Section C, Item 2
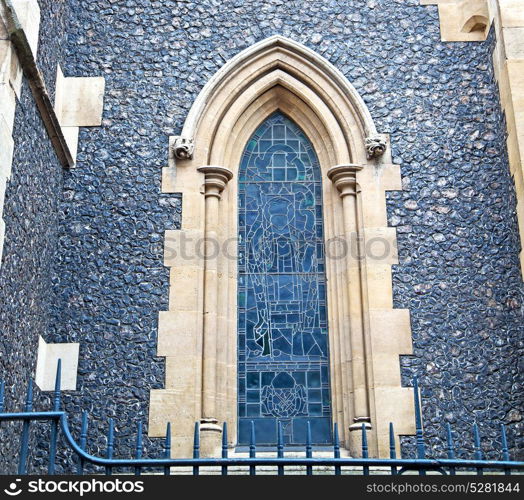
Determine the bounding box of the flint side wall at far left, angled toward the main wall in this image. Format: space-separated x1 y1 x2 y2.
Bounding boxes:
0 0 67 472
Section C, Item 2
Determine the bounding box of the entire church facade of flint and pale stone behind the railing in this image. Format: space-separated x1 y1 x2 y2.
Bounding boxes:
0 0 524 463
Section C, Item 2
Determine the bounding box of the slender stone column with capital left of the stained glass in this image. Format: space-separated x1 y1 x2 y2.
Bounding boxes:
198 166 233 456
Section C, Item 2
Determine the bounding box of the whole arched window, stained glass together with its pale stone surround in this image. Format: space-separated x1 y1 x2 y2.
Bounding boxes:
154 36 414 456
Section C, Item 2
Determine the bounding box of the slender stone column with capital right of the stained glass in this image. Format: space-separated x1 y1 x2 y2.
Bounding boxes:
327 165 371 438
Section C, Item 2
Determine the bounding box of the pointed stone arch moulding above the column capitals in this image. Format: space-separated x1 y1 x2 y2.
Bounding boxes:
172 35 385 168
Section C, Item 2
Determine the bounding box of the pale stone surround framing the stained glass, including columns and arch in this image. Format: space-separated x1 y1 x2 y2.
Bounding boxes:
149 36 414 456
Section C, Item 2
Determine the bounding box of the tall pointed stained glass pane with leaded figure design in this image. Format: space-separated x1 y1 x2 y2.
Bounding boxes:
238 113 331 444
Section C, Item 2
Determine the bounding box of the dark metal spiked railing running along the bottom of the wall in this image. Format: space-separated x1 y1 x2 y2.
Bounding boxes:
0 361 524 475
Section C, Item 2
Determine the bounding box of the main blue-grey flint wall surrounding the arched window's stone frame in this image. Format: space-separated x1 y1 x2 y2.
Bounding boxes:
0 0 524 468
